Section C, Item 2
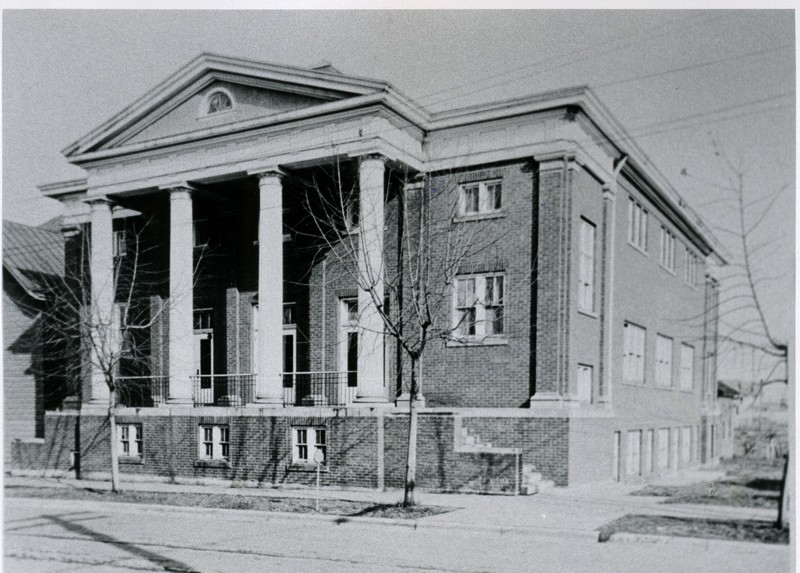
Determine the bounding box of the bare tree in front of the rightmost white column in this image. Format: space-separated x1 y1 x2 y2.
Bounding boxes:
303 163 529 506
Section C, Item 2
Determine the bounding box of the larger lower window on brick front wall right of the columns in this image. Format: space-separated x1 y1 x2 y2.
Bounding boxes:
453 274 505 339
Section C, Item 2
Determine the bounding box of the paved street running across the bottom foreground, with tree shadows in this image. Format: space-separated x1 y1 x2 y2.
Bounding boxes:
4 498 789 573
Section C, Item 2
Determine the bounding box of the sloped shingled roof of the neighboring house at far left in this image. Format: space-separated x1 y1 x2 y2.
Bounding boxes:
3 220 64 300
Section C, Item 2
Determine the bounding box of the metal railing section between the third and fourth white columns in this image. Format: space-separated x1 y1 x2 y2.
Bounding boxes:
282 372 357 406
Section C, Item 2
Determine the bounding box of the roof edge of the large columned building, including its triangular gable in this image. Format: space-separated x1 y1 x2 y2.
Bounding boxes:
48 53 727 264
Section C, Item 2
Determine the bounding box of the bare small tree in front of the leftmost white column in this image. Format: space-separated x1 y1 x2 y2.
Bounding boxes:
44 216 177 492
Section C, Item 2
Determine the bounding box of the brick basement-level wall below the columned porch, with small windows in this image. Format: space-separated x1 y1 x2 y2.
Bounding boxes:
42 410 569 493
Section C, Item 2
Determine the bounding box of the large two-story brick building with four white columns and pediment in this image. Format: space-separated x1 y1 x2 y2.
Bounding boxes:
36 54 724 490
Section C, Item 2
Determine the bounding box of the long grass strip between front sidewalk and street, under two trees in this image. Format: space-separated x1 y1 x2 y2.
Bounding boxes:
5 486 452 519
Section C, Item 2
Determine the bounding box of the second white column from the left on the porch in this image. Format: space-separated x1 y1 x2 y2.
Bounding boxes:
167 187 194 404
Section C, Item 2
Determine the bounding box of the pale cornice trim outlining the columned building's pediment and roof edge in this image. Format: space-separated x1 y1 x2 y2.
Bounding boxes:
50 53 727 264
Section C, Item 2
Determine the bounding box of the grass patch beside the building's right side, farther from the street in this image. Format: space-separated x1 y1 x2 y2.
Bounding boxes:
631 458 783 510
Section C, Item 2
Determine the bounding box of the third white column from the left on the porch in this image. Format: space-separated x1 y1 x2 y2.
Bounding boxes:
255 171 283 405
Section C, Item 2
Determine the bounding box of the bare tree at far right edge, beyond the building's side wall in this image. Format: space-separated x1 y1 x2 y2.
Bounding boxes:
683 141 789 528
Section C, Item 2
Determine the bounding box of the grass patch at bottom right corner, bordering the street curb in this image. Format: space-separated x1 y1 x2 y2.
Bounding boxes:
599 515 789 545
